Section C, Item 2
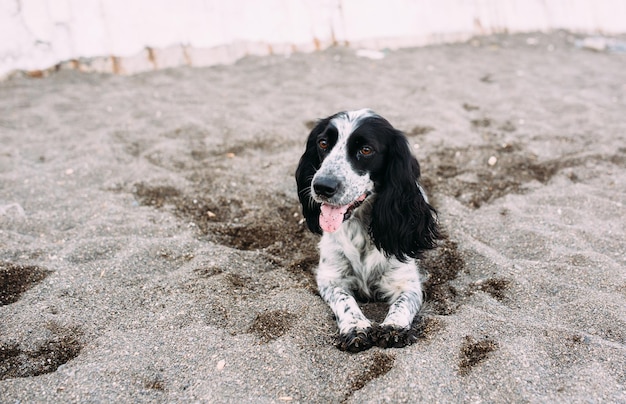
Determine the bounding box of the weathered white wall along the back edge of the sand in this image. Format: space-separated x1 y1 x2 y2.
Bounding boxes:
0 0 626 77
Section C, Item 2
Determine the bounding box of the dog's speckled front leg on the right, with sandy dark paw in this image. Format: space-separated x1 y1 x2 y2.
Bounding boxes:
375 262 424 348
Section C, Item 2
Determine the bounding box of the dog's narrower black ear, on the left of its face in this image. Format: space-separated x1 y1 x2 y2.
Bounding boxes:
296 118 330 234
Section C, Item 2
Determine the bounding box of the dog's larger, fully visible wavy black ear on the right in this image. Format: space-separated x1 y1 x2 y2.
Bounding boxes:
370 129 441 262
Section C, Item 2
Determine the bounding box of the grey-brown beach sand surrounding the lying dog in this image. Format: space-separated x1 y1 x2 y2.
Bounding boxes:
0 33 626 403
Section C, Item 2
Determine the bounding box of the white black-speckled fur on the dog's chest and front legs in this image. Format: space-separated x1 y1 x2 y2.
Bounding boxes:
316 199 423 334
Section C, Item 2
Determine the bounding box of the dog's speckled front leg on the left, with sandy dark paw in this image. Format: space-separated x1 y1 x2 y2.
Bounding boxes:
316 259 373 352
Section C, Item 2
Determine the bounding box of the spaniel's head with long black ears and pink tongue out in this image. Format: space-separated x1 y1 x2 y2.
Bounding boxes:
296 109 439 260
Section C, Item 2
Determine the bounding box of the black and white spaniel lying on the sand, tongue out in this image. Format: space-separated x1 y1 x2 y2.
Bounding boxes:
296 109 441 352
